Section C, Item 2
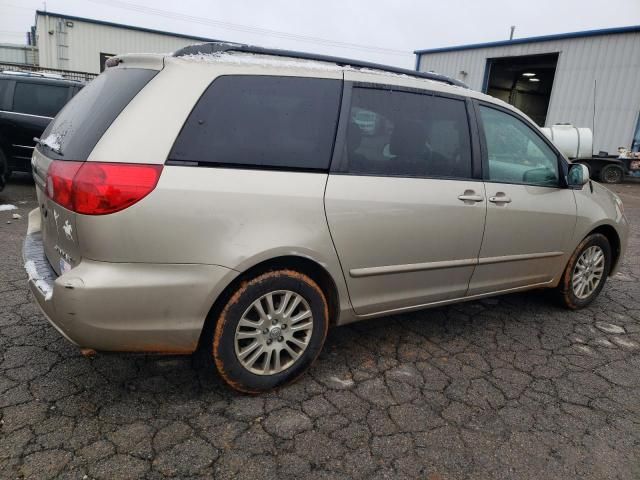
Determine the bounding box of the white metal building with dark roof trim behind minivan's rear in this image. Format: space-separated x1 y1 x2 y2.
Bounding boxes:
32 10 220 73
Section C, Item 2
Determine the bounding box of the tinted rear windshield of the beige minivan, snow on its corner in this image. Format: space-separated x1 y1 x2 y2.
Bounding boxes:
38 68 158 161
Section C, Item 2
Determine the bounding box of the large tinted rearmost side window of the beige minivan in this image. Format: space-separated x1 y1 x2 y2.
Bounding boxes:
169 75 342 170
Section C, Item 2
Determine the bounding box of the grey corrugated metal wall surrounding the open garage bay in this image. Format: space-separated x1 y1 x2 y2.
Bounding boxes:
419 33 640 153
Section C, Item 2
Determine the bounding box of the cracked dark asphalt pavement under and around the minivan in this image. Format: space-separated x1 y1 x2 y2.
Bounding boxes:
0 174 640 480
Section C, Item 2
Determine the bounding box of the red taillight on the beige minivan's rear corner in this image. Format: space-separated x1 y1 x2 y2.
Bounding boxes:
46 160 162 215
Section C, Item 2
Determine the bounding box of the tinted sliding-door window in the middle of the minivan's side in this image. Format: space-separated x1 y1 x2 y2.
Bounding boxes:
337 88 471 178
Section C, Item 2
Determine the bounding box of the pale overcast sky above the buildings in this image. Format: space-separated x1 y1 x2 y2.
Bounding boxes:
0 0 640 67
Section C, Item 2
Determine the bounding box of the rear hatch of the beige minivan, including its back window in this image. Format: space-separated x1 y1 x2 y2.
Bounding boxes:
31 67 158 275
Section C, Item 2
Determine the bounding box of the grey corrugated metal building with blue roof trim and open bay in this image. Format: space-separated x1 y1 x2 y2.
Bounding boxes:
414 25 640 153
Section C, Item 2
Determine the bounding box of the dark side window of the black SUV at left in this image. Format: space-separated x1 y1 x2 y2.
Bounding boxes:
13 82 69 117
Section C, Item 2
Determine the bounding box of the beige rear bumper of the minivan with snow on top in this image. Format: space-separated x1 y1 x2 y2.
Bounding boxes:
23 209 237 353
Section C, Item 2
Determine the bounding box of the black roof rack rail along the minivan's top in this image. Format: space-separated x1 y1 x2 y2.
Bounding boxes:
173 42 469 88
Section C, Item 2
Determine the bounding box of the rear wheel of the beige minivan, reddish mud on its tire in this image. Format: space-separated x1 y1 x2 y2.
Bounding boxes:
207 270 329 393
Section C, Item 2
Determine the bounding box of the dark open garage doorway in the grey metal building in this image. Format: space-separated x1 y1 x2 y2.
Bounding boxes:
484 53 558 127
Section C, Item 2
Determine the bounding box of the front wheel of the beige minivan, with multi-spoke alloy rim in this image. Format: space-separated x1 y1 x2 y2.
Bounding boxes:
557 233 611 310
